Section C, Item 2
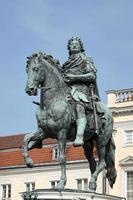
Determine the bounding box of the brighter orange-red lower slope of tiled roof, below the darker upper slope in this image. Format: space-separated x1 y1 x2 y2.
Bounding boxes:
0 147 85 167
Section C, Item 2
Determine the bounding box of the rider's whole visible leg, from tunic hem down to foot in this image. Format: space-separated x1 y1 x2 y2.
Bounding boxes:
74 104 87 146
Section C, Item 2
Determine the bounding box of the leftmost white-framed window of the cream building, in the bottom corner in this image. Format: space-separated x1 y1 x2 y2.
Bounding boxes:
2 184 11 200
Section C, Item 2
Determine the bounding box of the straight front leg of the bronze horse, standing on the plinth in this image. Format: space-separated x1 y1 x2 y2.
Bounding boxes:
56 129 67 190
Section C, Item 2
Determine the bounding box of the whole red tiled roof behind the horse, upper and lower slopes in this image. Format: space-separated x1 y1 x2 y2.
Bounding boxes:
0 134 96 168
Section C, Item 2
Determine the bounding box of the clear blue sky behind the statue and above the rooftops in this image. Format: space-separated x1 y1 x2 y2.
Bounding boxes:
0 0 133 136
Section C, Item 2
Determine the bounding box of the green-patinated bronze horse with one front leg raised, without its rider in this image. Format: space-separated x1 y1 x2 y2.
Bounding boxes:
23 52 116 191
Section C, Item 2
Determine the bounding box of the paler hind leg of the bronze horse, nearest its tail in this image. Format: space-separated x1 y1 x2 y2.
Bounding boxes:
89 147 106 191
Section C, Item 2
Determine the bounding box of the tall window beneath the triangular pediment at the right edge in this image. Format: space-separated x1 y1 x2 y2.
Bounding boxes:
127 171 133 200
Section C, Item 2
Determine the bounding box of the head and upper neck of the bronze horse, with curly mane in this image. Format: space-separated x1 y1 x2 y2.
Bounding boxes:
25 52 64 95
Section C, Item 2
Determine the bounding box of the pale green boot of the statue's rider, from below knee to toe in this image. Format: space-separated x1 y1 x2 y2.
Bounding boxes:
73 117 87 146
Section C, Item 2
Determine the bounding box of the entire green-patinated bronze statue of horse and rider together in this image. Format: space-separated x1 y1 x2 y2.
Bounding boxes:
23 37 116 191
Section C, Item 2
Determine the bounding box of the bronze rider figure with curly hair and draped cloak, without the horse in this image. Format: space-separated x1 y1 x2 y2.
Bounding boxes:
62 37 99 146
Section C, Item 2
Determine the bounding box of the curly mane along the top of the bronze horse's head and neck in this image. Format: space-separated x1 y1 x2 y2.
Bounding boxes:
27 51 61 71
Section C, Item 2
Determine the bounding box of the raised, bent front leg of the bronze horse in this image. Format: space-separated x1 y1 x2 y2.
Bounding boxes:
22 128 45 168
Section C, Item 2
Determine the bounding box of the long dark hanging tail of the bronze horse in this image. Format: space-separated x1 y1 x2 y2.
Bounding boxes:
105 136 117 188
